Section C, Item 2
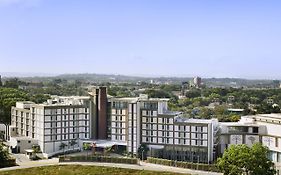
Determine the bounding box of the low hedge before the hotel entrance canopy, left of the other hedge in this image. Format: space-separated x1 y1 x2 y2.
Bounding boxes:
59 156 139 164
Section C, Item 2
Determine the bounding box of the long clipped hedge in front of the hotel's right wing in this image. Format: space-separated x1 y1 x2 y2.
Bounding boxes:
147 157 219 172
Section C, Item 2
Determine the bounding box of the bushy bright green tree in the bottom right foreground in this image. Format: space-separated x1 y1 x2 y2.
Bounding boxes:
217 143 276 175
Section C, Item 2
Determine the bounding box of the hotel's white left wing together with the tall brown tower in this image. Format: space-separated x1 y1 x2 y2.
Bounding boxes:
9 87 107 157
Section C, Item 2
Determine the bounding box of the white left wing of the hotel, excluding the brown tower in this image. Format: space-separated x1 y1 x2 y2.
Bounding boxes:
10 97 91 157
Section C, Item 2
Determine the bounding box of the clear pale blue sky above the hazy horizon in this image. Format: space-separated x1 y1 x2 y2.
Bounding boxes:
0 0 281 79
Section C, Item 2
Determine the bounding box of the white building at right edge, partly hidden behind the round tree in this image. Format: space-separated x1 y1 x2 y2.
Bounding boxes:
220 114 281 169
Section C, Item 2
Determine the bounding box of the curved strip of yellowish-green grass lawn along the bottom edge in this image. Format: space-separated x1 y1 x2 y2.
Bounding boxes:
0 165 188 175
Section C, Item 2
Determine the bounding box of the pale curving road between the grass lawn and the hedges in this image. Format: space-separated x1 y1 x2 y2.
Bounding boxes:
0 156 222 175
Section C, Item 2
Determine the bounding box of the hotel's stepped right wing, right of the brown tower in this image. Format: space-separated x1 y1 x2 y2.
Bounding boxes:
109 96 218 163
